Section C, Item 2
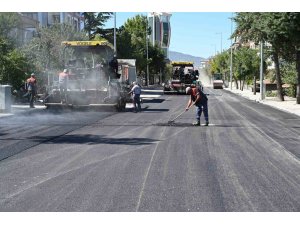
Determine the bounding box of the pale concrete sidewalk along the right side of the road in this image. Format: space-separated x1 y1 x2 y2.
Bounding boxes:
224 87 300 116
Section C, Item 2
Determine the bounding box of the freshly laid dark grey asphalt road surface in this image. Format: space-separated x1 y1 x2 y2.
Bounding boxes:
0 88 300 212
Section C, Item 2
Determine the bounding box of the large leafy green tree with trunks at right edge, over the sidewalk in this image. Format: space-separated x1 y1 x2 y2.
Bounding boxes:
233 12 300 104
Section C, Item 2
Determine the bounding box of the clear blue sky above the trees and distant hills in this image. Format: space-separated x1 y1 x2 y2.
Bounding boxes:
106 12 234 58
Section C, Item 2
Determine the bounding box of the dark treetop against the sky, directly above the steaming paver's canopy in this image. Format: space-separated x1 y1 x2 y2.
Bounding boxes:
82 12 112 40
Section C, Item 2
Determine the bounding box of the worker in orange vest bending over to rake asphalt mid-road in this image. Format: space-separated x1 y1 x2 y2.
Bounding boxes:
185 87 209 126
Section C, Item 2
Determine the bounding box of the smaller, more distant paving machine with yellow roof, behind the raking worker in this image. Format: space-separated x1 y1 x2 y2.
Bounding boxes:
163 61 199 94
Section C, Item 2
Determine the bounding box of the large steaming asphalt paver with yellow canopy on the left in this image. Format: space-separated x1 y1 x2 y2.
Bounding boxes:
44 41 130 111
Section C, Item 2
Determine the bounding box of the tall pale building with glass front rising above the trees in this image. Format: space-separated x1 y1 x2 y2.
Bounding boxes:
148 12 172 59
